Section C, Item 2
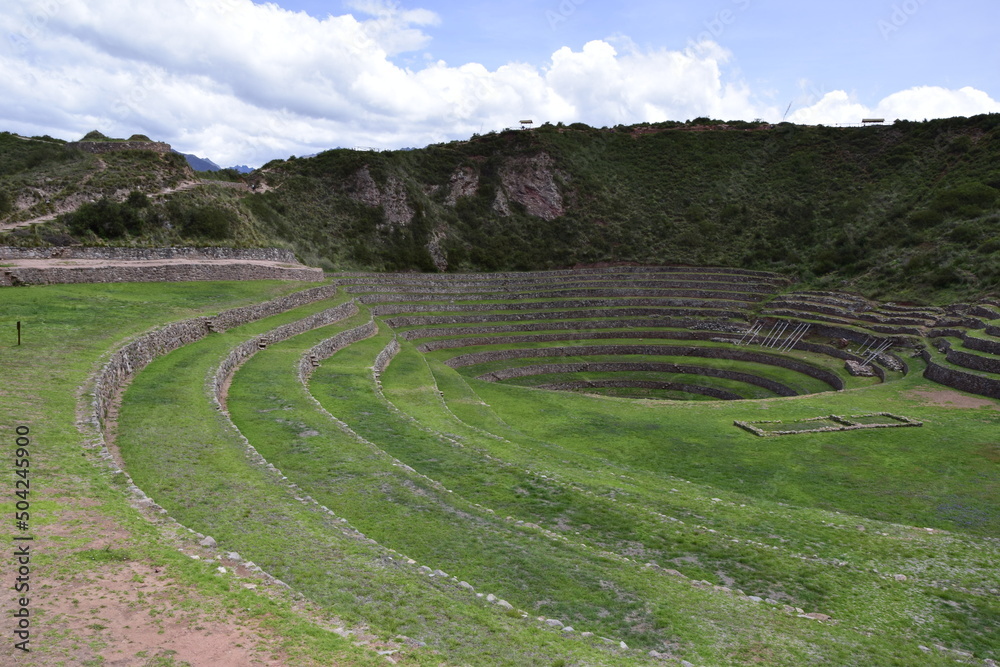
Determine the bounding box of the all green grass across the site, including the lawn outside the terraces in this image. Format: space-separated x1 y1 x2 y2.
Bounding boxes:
0 268 1000 666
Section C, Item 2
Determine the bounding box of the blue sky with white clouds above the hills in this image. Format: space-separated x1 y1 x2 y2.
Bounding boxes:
0 0 1000 167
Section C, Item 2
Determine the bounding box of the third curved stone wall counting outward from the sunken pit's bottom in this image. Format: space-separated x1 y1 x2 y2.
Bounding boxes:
445 345 844 390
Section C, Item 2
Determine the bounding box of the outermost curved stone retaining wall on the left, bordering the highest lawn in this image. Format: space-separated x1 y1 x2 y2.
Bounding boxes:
94 287 344 426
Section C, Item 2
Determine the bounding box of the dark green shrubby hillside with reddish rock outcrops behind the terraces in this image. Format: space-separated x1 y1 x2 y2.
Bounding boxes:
0 114 1000 302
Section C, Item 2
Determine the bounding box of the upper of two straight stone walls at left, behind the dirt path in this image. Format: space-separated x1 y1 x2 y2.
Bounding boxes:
0 246 298 264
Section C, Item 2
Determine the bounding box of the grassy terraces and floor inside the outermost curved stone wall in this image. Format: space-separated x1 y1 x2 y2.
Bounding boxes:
24 272 1000 665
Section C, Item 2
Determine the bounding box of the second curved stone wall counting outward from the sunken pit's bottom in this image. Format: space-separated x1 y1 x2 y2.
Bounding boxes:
477 361 798 396
